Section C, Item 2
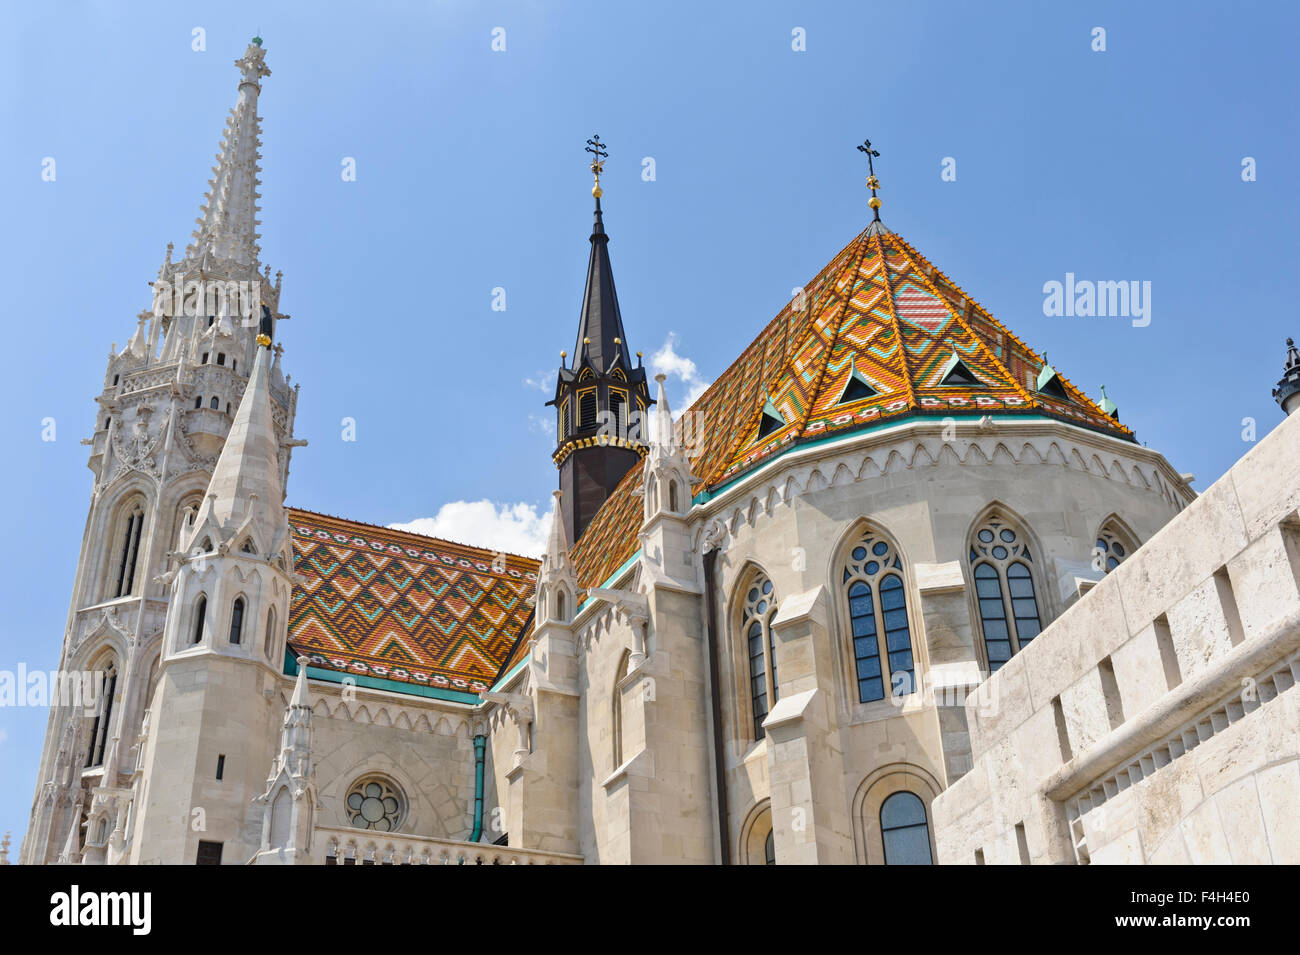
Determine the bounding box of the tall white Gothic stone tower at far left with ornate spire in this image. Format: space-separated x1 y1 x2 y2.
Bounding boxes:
20 38 300 864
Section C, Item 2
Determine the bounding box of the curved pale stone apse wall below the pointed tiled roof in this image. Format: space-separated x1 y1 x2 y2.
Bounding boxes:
697 421 1193 861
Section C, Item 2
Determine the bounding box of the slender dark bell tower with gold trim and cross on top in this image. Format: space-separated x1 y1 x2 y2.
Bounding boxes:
547 135 654 543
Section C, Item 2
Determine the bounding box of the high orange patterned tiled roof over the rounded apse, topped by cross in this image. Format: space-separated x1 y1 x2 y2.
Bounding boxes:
572 226 1132 586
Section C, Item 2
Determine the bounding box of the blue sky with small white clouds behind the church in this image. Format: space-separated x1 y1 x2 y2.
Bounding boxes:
0 1 1300 854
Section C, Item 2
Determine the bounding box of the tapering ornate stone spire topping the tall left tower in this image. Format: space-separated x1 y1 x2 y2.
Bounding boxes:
185 36 270 268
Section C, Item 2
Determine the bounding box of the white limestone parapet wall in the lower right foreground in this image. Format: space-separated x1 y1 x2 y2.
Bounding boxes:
935 416 1300 864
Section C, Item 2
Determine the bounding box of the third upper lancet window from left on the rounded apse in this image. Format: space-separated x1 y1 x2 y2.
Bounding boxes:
970 513 1043 673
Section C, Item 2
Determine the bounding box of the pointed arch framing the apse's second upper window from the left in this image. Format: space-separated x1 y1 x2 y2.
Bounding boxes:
831 518 917 703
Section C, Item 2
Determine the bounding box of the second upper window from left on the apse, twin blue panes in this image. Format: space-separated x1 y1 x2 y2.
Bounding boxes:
841 528 917 703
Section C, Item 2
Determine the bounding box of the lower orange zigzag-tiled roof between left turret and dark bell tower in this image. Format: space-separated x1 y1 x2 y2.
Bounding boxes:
289 509 540 693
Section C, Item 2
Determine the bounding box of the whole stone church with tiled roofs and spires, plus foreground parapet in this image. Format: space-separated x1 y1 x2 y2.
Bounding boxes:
20 39 1300 864
